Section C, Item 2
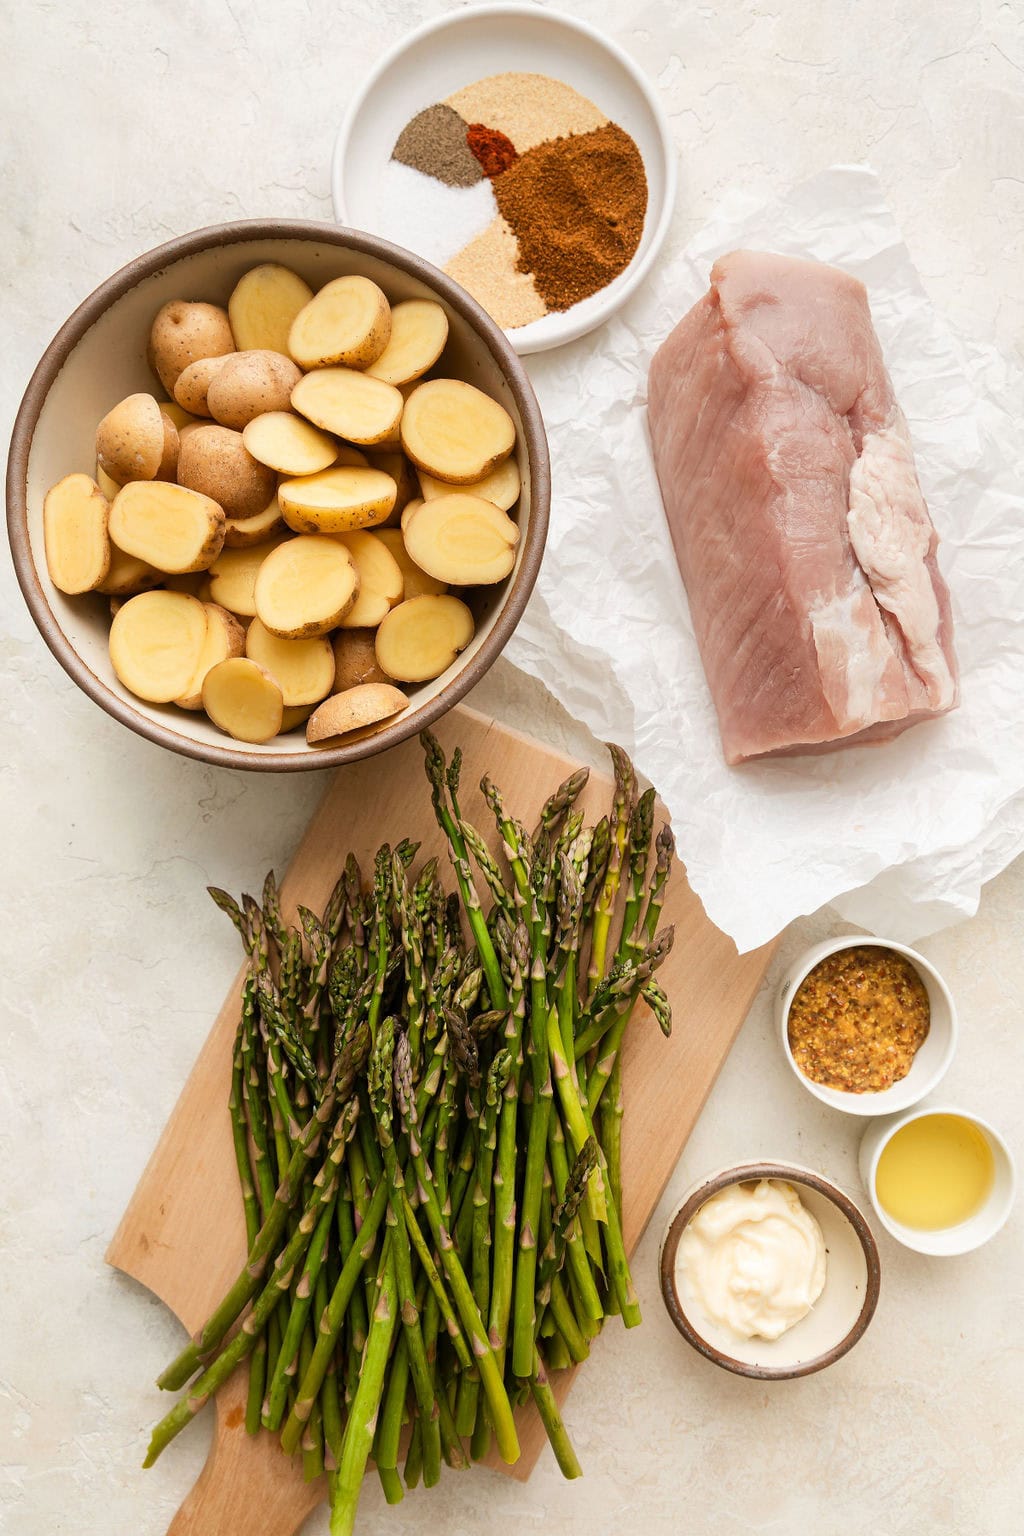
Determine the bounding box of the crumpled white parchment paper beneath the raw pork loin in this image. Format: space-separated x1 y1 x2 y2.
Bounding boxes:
507 166 1024 951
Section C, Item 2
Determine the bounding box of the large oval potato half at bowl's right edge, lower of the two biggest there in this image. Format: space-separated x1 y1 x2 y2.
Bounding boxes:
404 492 519 587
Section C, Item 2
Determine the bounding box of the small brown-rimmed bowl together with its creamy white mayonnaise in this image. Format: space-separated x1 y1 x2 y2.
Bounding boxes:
660 1163 880 1381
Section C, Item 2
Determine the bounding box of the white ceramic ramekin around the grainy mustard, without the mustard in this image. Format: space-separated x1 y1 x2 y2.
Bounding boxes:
775 934 958 1115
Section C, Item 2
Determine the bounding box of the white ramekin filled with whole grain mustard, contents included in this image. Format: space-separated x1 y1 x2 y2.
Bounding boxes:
777 934 958 1115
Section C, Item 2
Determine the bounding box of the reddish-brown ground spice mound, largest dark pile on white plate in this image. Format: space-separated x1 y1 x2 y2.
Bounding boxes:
493 123 648 309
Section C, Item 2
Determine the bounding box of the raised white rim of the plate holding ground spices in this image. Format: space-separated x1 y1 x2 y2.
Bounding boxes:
330 0 679 356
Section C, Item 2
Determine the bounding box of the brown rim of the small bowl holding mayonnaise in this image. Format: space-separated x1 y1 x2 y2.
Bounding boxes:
659 1161 881 1381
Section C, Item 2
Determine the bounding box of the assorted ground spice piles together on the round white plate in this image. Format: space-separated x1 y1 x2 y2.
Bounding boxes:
388 72 648 329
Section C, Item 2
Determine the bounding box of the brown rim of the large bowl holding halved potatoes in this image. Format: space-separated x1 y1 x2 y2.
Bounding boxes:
6 218 551 773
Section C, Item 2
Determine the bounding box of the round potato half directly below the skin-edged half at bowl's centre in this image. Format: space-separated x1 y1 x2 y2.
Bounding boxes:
253 536 359 641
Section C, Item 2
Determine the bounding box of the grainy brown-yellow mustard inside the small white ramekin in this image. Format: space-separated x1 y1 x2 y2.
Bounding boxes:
788 945 930 1094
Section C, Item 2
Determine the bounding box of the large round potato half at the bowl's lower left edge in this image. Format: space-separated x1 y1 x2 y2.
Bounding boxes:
109 591 207 703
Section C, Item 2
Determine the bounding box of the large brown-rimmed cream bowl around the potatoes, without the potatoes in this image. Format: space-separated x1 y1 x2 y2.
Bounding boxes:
8 220 551 771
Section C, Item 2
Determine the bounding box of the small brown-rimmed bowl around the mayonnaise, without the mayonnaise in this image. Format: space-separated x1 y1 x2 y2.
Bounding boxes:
660 1163 881 1381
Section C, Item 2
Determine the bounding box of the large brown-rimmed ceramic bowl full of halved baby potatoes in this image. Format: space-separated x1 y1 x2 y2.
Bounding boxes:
8 220 550 770
